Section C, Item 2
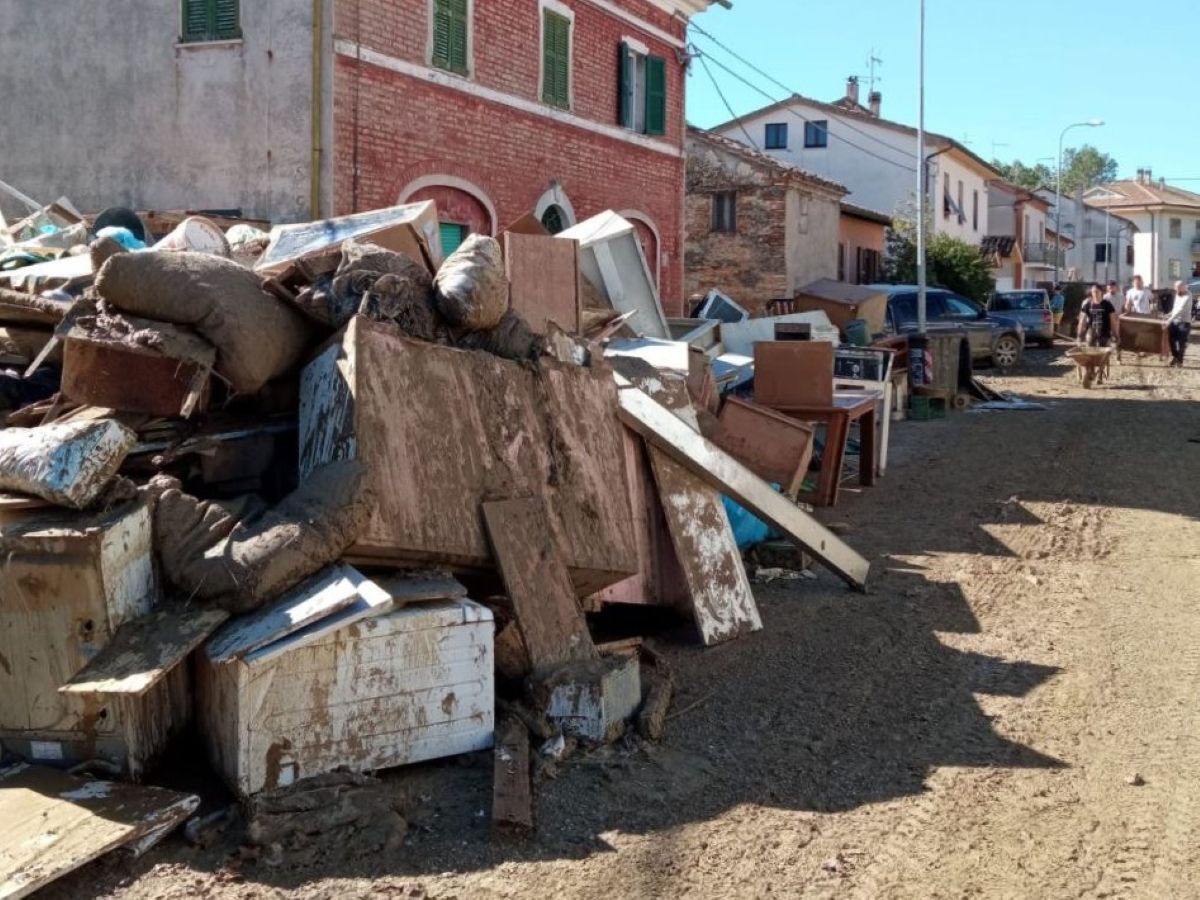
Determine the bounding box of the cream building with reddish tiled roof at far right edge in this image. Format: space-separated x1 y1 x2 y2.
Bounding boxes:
1084 169 1200 288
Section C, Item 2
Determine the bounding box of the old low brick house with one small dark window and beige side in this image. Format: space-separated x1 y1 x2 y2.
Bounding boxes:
684 128 846 313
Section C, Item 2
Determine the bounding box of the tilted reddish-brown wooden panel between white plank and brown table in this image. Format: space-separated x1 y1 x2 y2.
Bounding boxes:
713 397 812 498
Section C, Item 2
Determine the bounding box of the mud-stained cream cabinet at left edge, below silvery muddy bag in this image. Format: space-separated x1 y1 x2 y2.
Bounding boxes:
0 502 186 770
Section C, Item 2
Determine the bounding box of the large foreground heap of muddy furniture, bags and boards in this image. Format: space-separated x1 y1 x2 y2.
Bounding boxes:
0 192 868 890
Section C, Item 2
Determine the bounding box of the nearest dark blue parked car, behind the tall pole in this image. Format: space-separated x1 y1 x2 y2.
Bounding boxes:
870 284 1025 368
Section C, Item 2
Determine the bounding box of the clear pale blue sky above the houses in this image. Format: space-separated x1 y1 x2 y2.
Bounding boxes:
688 0 1200 192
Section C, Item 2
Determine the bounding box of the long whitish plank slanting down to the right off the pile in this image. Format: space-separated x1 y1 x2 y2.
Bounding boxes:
619 386 870 590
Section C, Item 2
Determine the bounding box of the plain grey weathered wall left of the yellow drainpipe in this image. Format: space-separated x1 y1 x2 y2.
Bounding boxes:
0 0 312 221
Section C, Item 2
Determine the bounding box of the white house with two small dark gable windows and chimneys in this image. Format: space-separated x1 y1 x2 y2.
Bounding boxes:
713 78 1000 244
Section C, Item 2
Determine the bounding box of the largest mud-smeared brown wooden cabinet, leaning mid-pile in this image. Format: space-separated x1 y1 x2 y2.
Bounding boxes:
300 318 637 595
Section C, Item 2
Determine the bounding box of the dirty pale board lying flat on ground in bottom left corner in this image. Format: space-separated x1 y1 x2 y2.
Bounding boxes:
0 766 200 900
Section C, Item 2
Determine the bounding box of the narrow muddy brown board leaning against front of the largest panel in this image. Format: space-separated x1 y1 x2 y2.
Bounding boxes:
484 499 598 670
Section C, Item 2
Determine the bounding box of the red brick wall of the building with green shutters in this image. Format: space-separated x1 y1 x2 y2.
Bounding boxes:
332 0 685 314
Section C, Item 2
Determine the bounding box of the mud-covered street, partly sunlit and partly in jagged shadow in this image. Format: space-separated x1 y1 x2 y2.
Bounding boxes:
44 346 1200 899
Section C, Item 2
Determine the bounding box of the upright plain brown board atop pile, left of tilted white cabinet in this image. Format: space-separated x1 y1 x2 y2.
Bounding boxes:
504 234 581 334
